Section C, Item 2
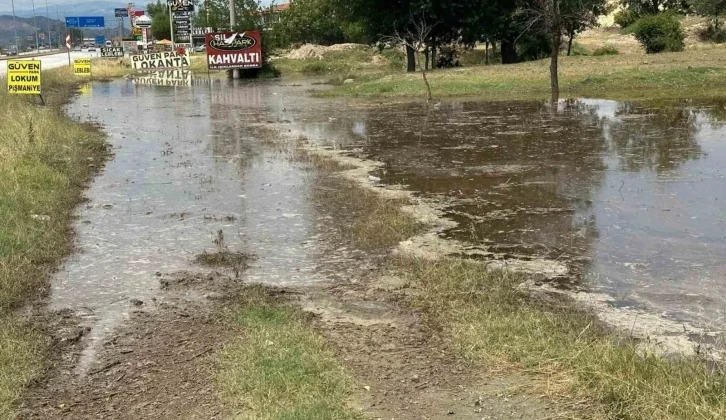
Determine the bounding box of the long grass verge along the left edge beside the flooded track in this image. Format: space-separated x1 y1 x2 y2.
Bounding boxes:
0 61 126 418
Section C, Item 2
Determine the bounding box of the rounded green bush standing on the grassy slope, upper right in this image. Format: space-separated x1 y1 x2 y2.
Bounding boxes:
633 13 685 54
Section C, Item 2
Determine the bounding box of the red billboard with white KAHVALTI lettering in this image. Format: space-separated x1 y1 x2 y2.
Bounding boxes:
206 31 262 70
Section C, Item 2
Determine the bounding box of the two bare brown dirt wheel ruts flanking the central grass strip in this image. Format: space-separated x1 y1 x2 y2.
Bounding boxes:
19 264 562 420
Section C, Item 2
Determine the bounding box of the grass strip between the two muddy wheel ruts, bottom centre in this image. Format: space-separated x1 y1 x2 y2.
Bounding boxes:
216 286 362 420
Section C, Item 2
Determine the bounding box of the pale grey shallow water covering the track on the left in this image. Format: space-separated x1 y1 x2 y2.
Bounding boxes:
57 81 366 373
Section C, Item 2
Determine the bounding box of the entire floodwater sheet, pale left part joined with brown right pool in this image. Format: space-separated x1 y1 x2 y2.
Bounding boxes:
59 76 726 370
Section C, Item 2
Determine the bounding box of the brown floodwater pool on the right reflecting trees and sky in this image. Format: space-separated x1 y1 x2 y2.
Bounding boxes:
272 93 726 330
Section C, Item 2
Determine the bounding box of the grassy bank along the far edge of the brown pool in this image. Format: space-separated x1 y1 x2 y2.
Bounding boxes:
330 48 726 100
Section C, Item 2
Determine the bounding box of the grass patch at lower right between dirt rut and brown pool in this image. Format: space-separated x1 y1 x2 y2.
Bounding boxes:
397 259 726 420
